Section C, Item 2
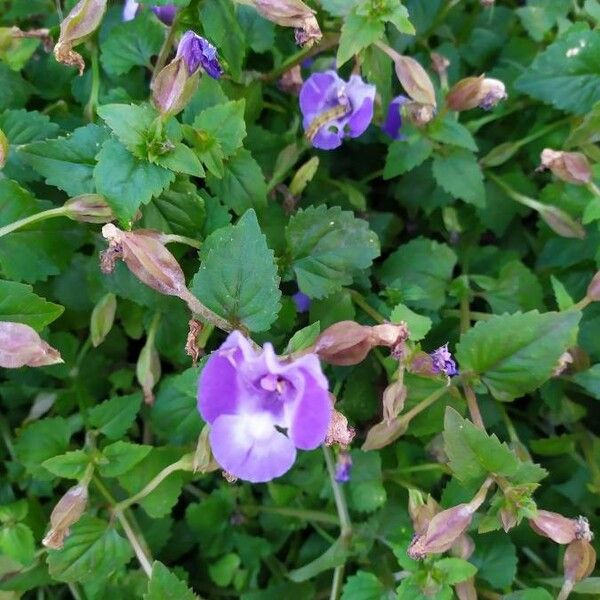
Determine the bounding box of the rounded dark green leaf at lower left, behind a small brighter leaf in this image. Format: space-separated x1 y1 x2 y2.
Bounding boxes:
15 417 71 481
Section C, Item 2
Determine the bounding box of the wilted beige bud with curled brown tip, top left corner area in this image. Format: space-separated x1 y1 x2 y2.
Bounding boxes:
54 0 107 75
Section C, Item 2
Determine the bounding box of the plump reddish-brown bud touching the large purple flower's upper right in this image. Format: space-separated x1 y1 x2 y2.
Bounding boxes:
314 321 374 365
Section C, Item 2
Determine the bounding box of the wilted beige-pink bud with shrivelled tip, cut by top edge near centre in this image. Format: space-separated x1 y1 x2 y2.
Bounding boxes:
250 0 323 47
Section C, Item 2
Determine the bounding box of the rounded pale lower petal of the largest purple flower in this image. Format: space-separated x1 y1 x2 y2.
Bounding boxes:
209 413 296 483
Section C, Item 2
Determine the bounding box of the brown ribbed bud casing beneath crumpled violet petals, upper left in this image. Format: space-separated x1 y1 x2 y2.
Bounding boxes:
152 57 200 115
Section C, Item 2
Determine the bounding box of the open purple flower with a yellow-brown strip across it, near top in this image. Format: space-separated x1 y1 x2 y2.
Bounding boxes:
300 71 375 150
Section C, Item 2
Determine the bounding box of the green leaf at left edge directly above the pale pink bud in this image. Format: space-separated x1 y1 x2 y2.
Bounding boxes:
0 279 64 331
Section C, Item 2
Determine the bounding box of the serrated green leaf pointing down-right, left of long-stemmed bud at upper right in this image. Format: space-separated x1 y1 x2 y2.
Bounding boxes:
433 148 485 208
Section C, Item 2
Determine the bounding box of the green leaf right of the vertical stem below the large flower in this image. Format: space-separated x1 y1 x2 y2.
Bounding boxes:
347 450 387 512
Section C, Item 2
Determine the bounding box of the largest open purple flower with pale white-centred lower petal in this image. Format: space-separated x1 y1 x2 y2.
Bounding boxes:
198 331 332 483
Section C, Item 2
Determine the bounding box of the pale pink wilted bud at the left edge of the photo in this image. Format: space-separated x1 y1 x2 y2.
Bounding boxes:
0 321 64 369
